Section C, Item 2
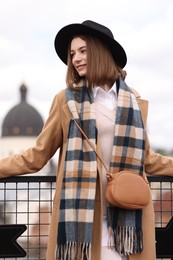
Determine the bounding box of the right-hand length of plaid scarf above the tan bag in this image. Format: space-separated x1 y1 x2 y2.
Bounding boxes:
110 78 145 174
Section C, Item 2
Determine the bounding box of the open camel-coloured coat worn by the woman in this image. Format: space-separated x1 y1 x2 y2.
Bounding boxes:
0 90 173 260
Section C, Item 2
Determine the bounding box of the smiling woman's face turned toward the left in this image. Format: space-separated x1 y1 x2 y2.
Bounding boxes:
70 37 87 77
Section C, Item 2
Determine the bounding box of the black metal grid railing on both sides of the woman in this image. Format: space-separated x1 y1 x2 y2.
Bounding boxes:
0 175 173 260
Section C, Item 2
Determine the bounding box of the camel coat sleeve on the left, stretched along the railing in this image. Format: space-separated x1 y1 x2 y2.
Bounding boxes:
0 94 62 178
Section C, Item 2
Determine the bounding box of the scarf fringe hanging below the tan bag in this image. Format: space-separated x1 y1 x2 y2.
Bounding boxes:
108 226 143 255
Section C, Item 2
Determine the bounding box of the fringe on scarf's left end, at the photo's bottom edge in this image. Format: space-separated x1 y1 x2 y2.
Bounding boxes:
56 242 91 260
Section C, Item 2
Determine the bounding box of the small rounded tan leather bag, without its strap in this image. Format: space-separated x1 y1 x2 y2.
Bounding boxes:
106 170 150 210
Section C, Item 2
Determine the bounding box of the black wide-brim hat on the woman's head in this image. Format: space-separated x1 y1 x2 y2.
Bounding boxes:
54 20 127 68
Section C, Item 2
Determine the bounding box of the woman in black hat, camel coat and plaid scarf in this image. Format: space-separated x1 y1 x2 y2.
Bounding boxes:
0 21 173 260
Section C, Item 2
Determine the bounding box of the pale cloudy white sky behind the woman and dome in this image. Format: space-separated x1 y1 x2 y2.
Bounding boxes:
0 0 173 150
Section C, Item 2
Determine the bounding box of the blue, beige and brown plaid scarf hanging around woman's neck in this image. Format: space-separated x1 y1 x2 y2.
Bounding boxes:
56 77 145 260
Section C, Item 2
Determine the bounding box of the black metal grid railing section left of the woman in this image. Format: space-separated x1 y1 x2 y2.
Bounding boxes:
0 176 55 260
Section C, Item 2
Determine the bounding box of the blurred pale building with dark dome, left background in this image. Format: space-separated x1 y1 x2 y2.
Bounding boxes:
0 84 55 174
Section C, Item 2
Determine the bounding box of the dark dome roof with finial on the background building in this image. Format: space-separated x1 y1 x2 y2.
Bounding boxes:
2 84 43 137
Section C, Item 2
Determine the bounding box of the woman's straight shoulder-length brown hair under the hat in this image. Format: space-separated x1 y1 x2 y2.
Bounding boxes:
66 35 126 88
